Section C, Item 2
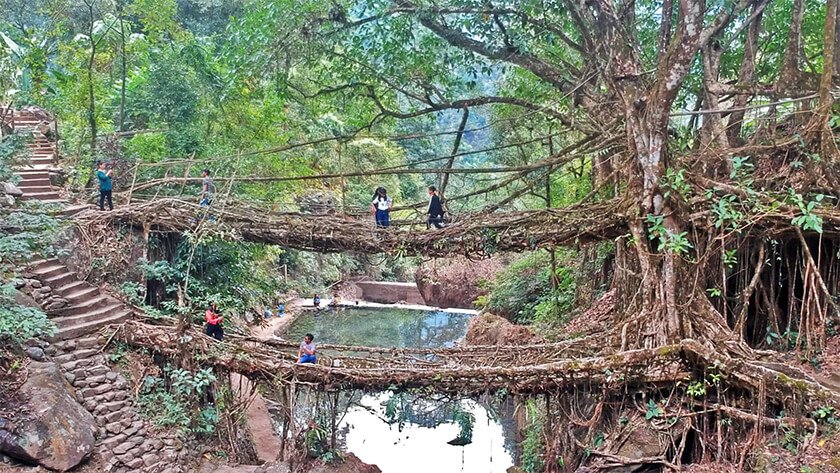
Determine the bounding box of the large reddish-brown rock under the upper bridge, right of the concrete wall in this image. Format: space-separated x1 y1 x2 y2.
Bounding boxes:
414 256 507 309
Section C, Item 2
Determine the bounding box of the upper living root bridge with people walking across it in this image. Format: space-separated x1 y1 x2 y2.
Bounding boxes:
76 198 626 256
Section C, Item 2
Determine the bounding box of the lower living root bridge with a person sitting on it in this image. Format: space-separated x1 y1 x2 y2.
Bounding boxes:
115 321 840 406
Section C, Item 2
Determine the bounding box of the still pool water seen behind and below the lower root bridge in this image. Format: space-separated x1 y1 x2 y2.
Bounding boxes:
283 308 515 473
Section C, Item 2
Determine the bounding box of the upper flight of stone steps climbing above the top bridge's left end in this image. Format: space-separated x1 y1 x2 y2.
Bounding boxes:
0 109 65 204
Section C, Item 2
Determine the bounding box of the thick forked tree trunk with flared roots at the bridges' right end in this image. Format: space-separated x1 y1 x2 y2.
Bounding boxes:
613 0 728 347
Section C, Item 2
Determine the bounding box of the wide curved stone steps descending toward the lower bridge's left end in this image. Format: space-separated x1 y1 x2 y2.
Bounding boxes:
24 258 131 340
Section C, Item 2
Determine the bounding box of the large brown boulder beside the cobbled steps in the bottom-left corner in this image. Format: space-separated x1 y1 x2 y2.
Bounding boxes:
0 361 96 471
